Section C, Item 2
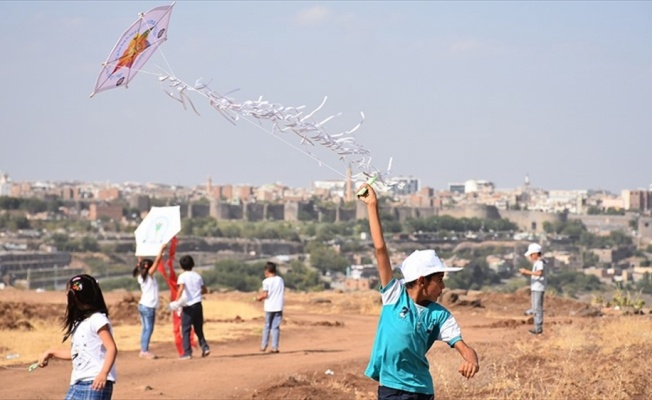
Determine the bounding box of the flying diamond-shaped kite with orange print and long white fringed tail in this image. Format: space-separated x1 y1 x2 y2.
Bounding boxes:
91 3 393 190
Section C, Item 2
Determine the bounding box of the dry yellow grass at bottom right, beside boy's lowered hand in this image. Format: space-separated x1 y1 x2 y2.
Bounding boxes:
430 316 652 399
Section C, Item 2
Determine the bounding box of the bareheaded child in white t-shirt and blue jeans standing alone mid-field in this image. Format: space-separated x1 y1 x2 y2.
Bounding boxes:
254 262 285 353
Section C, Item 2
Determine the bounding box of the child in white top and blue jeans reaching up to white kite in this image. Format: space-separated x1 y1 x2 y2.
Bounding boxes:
133 243 167 360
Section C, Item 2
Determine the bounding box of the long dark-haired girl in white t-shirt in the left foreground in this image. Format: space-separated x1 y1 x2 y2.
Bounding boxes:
38 274 118 400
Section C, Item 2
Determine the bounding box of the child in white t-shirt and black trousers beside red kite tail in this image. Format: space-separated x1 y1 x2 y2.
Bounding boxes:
176 256 211 360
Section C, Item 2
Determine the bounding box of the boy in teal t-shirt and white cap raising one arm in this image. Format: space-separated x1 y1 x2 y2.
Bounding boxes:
358 184 480 400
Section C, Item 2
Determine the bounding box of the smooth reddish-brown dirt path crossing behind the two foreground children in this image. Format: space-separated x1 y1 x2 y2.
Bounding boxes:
0 304 526 399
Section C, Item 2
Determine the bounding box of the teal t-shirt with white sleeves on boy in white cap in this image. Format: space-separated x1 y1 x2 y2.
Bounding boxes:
365 279 462 394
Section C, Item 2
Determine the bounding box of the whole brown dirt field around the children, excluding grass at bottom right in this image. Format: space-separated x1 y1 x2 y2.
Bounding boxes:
0 290 600 399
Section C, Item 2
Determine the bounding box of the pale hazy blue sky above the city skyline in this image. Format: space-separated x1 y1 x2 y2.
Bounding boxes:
0 1 652 191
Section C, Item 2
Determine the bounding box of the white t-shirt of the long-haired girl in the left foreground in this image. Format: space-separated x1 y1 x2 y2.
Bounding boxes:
70 313 117 385
